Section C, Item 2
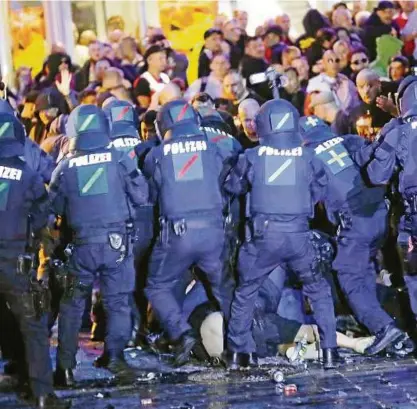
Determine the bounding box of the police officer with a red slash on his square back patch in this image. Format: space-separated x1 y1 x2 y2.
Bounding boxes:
144 100 233 365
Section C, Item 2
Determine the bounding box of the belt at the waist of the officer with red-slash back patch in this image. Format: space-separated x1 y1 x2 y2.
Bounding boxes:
158 215 222 244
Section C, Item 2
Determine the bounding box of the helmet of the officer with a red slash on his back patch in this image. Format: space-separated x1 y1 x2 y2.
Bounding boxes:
155 99 200 140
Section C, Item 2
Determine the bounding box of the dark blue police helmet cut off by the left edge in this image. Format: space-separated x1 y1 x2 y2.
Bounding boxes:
0 112 26 156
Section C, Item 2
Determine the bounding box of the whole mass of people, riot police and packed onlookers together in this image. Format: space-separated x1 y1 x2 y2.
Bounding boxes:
0 1 417 408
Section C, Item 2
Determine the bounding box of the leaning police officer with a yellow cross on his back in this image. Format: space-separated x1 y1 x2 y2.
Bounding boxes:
300 116 407 355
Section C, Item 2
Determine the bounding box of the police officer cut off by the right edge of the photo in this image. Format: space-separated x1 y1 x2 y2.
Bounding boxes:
362 76 417 332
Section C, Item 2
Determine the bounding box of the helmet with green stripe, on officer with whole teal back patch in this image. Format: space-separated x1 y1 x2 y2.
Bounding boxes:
66 105 110 151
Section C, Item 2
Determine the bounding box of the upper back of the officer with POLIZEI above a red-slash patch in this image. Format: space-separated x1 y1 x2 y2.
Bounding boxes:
144 100 225 218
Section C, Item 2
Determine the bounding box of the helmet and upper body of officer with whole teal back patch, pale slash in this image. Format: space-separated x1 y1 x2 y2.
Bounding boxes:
51 106 147 237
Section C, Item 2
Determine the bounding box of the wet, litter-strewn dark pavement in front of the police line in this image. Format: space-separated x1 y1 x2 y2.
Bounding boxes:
0 334 417 409
